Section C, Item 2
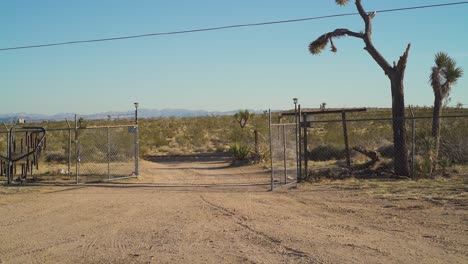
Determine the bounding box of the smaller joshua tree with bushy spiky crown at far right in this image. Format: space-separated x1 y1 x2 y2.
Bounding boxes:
429 52 463 170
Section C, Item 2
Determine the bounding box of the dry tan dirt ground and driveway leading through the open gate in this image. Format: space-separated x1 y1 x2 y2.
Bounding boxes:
0 158 468 263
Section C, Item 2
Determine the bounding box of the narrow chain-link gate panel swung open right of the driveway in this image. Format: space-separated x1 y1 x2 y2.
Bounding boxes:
270 124 298 189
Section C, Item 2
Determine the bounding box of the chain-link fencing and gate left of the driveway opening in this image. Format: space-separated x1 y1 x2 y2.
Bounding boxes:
0 125 138 183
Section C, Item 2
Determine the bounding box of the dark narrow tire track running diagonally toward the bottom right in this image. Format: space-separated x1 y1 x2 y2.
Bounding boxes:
200 195 325 263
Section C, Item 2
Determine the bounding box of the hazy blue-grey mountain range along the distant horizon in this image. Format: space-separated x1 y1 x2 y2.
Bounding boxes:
0 109 261 123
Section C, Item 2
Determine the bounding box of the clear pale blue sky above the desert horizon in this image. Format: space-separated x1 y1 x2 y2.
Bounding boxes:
0 0 468 114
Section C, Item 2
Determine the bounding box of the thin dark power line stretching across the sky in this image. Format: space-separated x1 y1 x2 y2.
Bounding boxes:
0 1 468 51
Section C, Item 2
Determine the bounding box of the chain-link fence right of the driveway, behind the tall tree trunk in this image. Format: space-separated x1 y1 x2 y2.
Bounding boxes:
302 116 468 178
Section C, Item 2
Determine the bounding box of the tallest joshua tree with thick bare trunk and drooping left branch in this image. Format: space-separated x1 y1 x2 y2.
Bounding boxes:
309 0 411 176
